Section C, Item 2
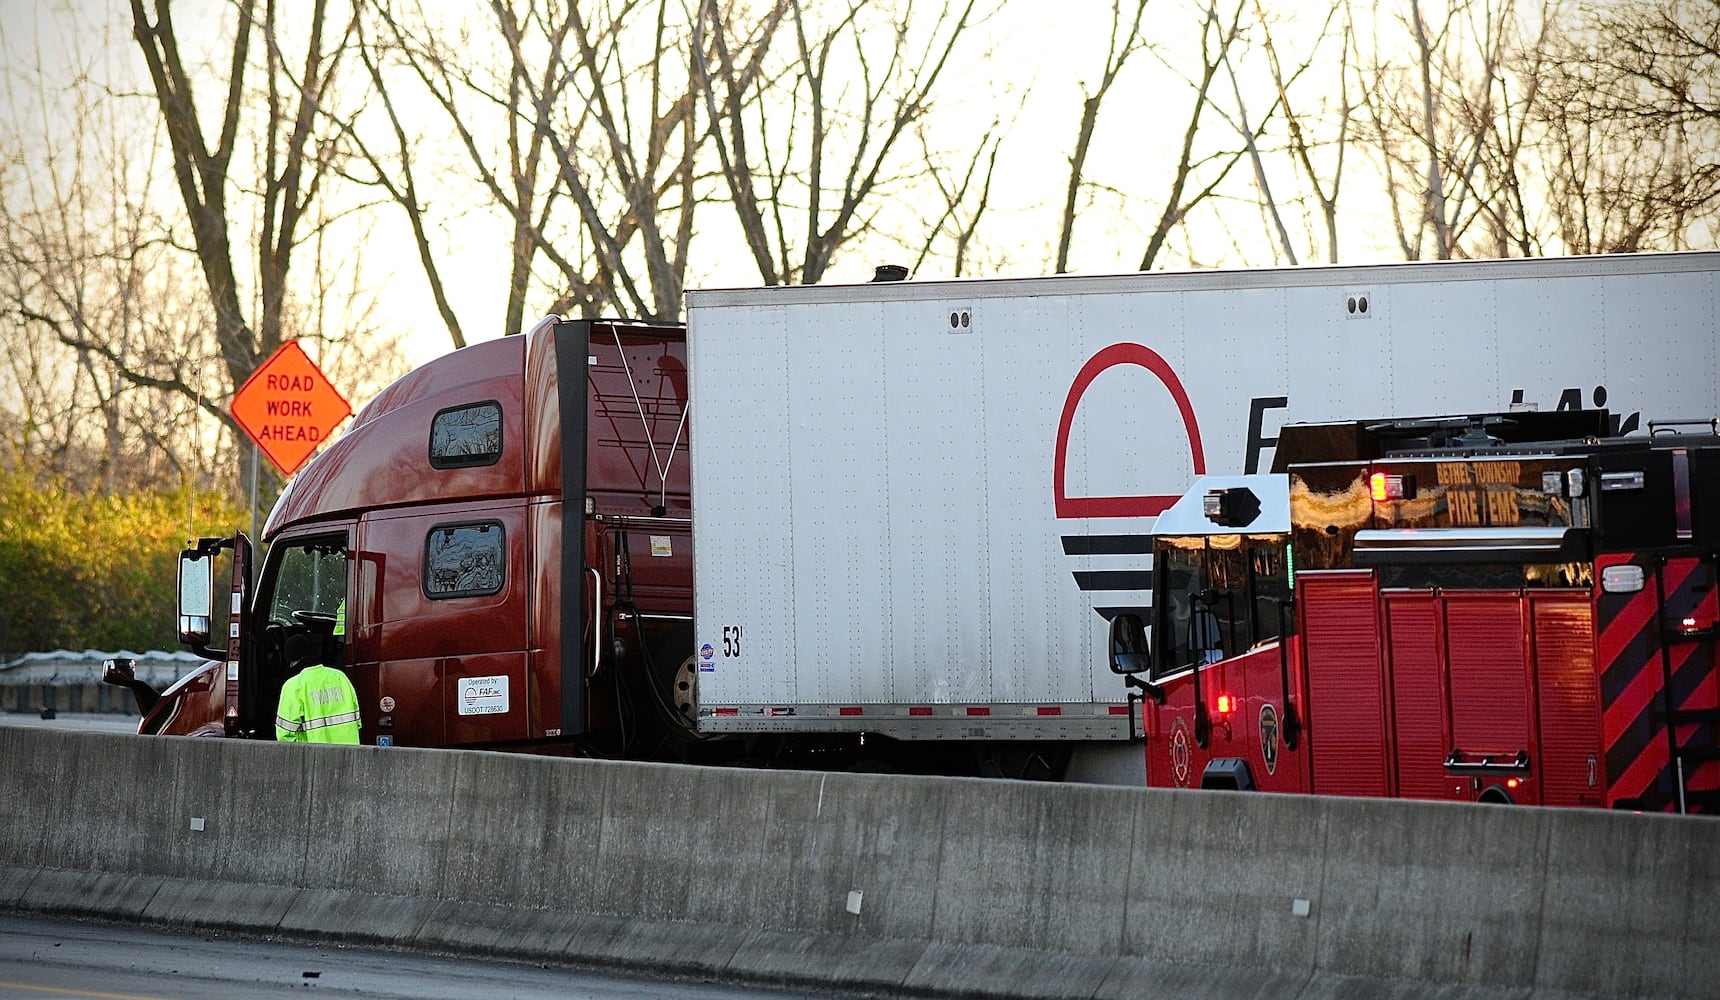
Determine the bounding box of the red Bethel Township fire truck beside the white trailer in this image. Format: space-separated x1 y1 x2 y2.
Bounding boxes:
1111 410 1720 812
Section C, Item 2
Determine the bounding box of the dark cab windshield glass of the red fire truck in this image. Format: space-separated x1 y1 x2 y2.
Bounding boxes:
1152 535 1290 675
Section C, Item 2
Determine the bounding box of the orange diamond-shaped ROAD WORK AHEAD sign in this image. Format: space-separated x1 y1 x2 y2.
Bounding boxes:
230 341 353 475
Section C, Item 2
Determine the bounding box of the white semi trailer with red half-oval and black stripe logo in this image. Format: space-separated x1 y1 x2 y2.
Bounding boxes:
686 253 1720 783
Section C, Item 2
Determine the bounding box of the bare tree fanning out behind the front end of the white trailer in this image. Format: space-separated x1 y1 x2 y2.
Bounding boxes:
693 0 994 284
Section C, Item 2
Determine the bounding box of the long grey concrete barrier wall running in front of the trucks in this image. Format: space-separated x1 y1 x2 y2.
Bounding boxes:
0 728 1720 997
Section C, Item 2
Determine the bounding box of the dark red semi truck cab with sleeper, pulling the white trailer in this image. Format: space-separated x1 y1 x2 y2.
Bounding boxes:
110 317 695 754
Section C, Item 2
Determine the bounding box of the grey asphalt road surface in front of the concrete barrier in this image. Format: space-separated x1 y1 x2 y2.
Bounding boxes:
0 914 825 1000
